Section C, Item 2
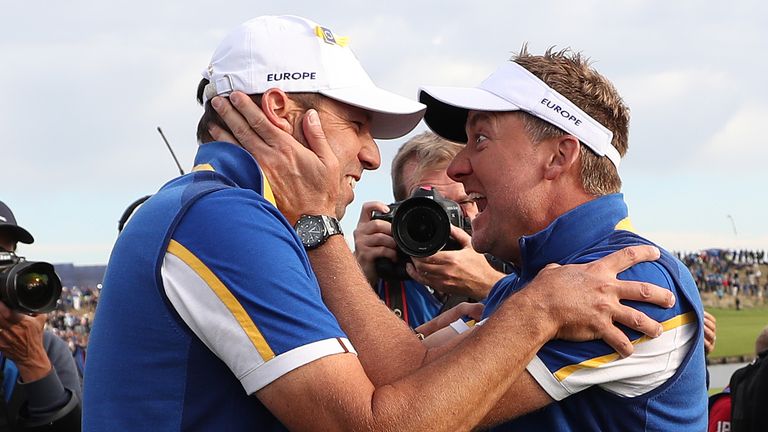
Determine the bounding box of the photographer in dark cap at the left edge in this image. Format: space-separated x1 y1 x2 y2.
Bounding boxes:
0 202 81 431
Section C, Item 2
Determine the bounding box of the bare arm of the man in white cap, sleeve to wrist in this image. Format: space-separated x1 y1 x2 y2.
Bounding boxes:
282 290 553 431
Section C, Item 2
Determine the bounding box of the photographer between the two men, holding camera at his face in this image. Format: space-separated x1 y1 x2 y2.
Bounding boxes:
354 132 504 328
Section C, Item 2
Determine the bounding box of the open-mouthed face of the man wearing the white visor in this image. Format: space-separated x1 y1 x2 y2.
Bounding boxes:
448 111 548 263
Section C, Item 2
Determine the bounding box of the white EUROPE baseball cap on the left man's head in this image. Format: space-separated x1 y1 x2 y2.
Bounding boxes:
202 15 426 139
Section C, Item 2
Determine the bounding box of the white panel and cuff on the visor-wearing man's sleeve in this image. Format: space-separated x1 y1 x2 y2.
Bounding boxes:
526 322 698 401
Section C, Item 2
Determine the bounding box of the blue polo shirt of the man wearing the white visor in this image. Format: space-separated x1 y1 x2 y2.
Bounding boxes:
484 194 707 431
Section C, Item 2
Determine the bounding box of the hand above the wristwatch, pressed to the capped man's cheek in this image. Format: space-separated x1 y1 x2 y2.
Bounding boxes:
209 92 339 224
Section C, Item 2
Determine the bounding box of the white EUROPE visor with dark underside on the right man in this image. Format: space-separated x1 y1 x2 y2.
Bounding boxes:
419 62 621 169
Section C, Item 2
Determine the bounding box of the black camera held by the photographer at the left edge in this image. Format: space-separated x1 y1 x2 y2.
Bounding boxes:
0 251 61 313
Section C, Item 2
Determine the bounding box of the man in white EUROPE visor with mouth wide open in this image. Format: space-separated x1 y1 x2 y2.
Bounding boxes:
419 49 707 431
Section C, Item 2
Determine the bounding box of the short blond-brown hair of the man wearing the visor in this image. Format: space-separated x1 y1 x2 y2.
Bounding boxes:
512 45 629 195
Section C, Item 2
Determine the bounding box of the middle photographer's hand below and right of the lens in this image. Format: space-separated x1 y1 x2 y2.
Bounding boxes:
406 225 504 300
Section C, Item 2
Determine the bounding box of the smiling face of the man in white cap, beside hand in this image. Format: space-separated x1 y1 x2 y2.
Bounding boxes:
294 97 381 219
